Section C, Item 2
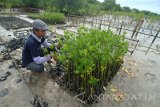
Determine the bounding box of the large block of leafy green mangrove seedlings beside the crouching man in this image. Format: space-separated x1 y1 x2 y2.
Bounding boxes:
42 27 128 104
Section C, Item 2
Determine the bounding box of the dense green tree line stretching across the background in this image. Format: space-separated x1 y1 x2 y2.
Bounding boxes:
0 0 160 16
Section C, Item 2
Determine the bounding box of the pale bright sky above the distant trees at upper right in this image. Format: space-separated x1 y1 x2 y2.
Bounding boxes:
98 0 160 14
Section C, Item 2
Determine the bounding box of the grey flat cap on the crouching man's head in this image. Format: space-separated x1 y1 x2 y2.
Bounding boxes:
32 19 48 30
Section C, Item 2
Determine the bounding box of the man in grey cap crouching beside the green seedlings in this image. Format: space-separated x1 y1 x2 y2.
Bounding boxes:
22 19 55 73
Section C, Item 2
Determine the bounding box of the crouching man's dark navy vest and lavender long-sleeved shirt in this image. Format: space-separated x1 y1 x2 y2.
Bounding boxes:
22 33 51 67
